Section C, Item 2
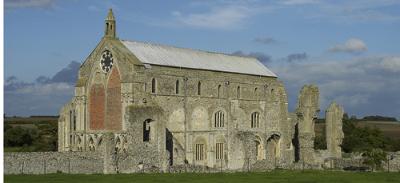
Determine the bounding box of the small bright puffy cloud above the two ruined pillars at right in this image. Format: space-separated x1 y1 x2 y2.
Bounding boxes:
329 38 367 53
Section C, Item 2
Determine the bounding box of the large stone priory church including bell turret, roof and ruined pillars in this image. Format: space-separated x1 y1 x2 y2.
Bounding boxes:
58 10 343 172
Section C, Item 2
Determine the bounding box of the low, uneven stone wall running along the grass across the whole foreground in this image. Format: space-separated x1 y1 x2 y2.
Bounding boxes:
4 152 400 174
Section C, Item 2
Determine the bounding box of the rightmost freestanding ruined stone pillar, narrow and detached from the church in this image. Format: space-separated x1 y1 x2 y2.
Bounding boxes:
325 102 344 158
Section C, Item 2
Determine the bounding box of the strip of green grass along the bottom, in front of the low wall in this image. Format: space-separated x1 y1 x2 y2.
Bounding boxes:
4 171 400 183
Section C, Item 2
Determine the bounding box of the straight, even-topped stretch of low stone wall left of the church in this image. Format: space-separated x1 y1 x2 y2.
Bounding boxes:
4 152 104 174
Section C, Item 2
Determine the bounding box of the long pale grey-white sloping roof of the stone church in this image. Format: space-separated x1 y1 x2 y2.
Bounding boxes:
122 40 277 77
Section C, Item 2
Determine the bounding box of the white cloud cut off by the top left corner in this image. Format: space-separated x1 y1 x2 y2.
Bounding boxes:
4 0 54 9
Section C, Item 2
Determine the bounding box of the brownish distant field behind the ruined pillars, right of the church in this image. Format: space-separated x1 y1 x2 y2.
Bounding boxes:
315 121 400 139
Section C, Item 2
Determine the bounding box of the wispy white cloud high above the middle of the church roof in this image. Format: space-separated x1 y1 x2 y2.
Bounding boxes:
172 6 251 29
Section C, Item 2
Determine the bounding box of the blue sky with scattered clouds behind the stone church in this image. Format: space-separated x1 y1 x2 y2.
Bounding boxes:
4 0 400 117
